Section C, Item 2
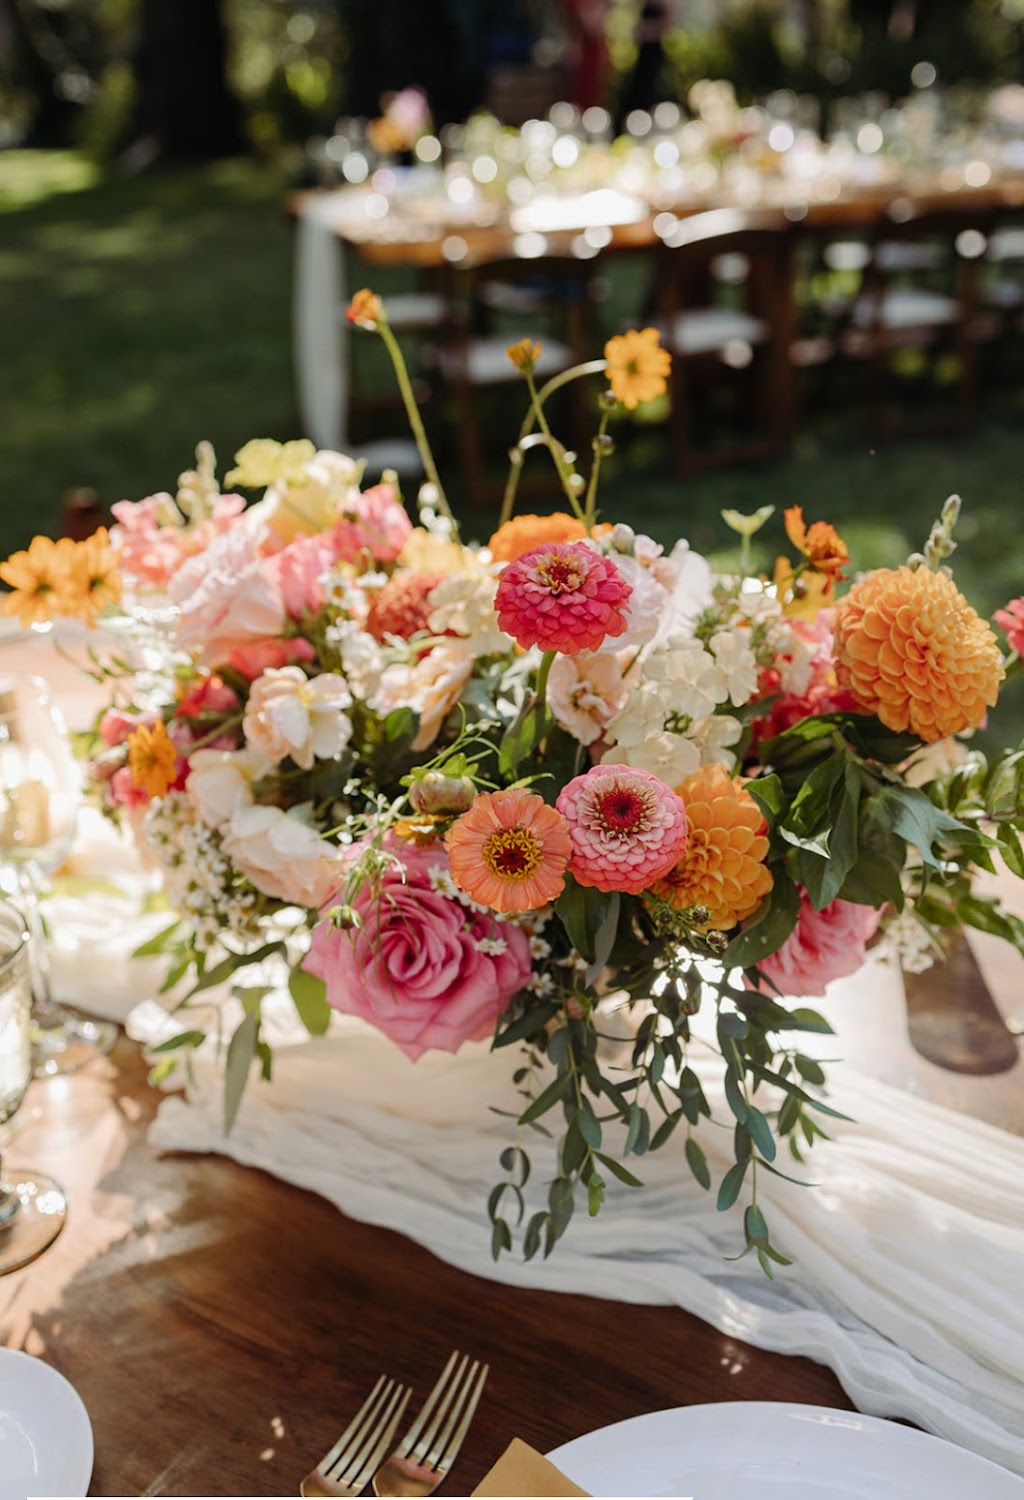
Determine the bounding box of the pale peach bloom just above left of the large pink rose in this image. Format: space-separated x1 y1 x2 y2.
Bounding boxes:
220 804 343 911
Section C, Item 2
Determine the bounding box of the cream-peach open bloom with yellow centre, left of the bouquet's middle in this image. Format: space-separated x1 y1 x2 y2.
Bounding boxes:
241 666 352 771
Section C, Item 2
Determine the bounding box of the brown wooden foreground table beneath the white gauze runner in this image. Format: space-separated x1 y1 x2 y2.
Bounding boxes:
0 627 1024 1496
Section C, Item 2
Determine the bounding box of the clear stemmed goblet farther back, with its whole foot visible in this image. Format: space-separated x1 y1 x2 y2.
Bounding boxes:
0 672 117 1076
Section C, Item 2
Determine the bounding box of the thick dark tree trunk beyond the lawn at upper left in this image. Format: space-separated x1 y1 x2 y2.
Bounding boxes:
132 0 246 161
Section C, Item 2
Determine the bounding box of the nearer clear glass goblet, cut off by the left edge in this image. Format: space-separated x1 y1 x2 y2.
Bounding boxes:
0 902 67 1277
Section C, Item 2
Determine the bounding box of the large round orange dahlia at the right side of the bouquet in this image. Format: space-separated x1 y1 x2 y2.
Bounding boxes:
832 567 1005 741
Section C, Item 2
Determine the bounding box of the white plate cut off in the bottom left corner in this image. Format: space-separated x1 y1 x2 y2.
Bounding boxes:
0 1349 93 1500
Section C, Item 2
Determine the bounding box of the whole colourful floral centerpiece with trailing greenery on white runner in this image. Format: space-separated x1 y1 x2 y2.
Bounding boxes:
8 293 1024 1274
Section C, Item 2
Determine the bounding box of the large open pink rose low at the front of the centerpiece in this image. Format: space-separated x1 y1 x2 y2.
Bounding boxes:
303 840 531 1062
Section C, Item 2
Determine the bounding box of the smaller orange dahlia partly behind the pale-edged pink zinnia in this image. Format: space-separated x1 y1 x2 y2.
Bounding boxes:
654 765 772 932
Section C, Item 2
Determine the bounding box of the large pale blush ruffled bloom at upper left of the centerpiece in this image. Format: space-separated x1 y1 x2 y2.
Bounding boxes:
168 522 285 666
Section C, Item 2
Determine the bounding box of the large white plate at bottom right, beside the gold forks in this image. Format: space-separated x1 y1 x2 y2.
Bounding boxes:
547 1401 1024 1500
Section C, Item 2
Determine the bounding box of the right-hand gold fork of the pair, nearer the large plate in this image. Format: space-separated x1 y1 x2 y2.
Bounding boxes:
373 1350 490 1496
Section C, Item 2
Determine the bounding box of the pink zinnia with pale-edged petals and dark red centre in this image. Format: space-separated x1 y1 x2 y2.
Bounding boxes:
555 765 687 896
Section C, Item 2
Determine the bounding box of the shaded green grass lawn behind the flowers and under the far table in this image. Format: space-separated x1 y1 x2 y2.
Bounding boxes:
0 153 1024 744
